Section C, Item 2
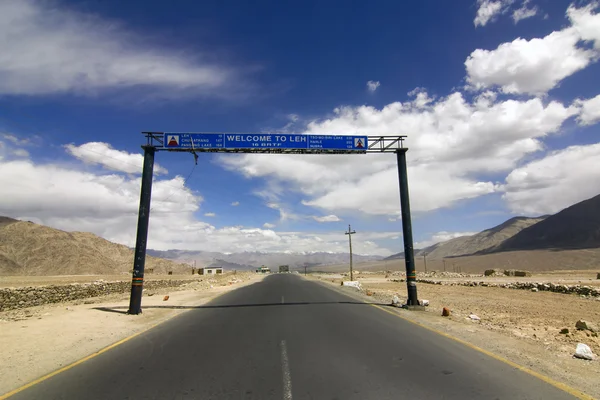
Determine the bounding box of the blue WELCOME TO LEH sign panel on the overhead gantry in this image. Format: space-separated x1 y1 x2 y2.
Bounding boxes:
164 133 369 151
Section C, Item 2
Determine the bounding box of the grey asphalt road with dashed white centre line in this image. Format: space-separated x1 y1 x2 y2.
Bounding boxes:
11 274 573 400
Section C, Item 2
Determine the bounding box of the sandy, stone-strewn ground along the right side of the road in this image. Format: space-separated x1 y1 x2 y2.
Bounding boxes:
313 274 600 398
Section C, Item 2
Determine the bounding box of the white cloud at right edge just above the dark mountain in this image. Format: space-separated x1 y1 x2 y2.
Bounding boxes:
503 143 600 216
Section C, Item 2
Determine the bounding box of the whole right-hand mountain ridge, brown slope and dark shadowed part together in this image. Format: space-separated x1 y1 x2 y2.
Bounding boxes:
385 195 600 260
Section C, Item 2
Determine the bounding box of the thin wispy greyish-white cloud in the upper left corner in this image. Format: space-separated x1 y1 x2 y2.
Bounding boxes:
0 0 244 96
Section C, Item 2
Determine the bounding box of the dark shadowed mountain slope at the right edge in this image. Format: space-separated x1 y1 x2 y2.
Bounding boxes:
486 195 600 252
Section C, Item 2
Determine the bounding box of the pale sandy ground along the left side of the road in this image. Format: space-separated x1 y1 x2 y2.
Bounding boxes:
0 273 264 394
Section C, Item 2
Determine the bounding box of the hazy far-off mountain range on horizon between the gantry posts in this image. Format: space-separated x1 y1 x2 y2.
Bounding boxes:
147 250 383 270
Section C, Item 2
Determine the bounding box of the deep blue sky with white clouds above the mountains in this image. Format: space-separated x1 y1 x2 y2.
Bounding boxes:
0 0 600 256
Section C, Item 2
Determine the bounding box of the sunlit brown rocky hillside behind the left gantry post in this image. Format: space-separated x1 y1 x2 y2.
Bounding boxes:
0 217 190 275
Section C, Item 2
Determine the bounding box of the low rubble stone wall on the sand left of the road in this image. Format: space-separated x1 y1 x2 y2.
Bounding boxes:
0 279 193 311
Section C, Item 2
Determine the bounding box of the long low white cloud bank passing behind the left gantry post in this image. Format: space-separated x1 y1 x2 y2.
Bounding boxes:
0 136 397 255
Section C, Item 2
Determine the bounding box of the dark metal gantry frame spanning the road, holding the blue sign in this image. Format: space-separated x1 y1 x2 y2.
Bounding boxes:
128 132 419 314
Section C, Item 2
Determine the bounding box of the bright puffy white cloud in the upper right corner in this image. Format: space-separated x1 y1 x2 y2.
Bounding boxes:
465 6 600 94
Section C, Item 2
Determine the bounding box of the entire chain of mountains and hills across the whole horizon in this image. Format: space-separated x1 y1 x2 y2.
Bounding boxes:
0 195 600 275
